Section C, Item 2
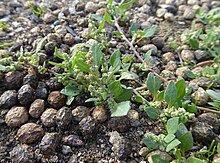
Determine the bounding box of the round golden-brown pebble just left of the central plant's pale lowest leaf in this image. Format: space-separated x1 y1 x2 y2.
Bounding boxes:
92 106 108 123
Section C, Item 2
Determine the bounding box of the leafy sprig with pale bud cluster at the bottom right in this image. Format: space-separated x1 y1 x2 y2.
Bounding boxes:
143 117 193 158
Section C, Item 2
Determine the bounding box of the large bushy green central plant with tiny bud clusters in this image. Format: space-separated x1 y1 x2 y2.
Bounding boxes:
50 43 133 116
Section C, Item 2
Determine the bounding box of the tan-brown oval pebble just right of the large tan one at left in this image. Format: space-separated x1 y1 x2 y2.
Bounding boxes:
29 99 44 118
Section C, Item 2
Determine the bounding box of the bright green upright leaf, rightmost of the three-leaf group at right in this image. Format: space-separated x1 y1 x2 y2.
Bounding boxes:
176 79 186 102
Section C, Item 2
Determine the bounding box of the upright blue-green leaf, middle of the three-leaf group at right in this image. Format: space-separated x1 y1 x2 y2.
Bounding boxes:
164 81 177 107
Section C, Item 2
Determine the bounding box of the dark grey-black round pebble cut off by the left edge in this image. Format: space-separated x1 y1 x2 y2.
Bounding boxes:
0 90 18 109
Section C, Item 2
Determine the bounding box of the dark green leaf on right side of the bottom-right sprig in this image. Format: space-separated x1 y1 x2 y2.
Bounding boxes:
179 132 193 152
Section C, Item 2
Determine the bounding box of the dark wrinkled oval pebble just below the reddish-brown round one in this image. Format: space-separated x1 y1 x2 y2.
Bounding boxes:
56 106 73 130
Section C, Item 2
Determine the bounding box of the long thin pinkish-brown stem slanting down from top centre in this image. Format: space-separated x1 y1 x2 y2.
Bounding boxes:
114 16 167 82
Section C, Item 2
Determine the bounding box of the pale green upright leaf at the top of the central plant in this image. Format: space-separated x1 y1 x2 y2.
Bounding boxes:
91 44 104 67
